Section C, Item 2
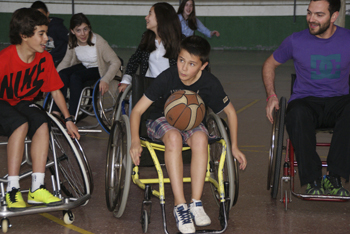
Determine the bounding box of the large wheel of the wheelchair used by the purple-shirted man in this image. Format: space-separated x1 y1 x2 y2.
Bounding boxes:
267 97 286 199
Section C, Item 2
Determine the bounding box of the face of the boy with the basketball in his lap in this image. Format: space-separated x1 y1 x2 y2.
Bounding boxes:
177 49 208 85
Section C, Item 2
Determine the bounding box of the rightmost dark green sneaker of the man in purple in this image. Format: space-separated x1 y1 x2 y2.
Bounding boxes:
322 175 350 197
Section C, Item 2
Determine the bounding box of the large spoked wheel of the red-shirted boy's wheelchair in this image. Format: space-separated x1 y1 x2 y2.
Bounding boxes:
47 114 93 200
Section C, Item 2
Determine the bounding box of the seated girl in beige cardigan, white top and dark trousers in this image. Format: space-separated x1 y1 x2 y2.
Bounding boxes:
53 13 121 115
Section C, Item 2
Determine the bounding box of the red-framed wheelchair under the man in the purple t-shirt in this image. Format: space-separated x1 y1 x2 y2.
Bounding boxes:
267 74 350 210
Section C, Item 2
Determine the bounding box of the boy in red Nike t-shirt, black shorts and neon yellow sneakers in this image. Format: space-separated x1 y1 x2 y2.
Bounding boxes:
0 8 80 210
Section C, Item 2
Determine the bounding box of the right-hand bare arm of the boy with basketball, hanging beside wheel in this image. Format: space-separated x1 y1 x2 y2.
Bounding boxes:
224 102 247 170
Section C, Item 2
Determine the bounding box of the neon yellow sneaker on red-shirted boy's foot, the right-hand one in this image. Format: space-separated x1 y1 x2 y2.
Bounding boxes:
28 185 62 206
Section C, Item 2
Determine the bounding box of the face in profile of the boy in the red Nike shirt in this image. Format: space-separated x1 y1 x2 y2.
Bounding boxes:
21 25 48 53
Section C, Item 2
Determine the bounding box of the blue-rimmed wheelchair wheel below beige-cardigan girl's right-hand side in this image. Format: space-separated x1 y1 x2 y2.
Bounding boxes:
93 79 119 134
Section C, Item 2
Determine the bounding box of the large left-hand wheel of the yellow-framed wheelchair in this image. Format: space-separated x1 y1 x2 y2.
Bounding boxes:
105 115 132 218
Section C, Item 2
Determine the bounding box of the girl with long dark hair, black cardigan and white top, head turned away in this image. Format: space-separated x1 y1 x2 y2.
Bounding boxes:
119 2 182 92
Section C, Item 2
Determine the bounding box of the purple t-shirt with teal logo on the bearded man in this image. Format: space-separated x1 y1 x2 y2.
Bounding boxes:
273 27 350 101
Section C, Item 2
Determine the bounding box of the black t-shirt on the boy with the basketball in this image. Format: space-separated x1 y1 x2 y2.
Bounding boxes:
145 66 230 120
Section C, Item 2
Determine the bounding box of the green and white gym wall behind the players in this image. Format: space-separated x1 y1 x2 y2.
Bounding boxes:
0 0 350 50
